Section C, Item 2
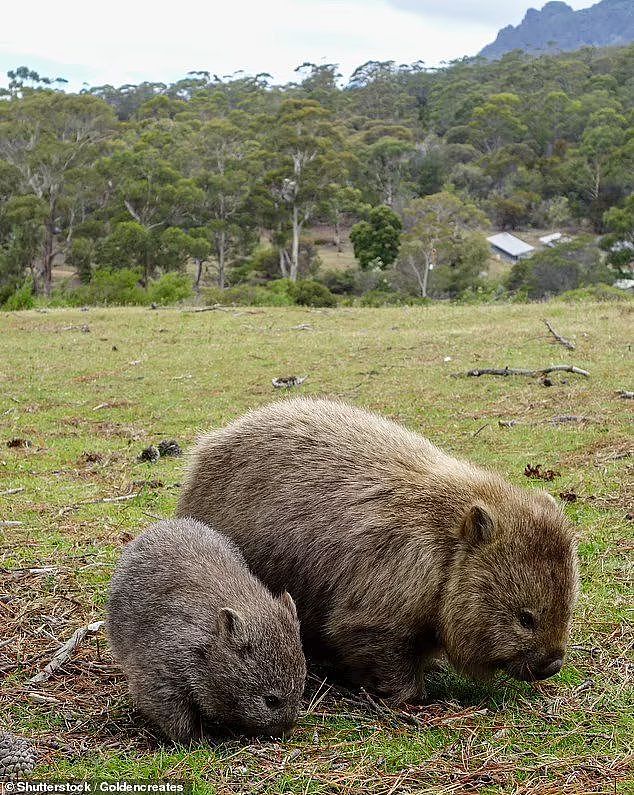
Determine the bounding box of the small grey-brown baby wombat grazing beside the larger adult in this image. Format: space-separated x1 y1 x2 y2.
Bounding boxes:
108 519 306 743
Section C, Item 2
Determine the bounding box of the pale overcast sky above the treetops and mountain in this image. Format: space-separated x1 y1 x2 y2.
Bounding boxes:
0 0 596 88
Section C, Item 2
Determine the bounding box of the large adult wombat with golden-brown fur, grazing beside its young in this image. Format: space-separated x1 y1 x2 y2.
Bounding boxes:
178 399 578 701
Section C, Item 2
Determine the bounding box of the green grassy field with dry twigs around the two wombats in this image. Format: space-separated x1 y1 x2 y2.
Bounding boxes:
0 304 634 795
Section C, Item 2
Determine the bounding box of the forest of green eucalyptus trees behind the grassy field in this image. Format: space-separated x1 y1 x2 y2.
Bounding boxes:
0 46 634 305
